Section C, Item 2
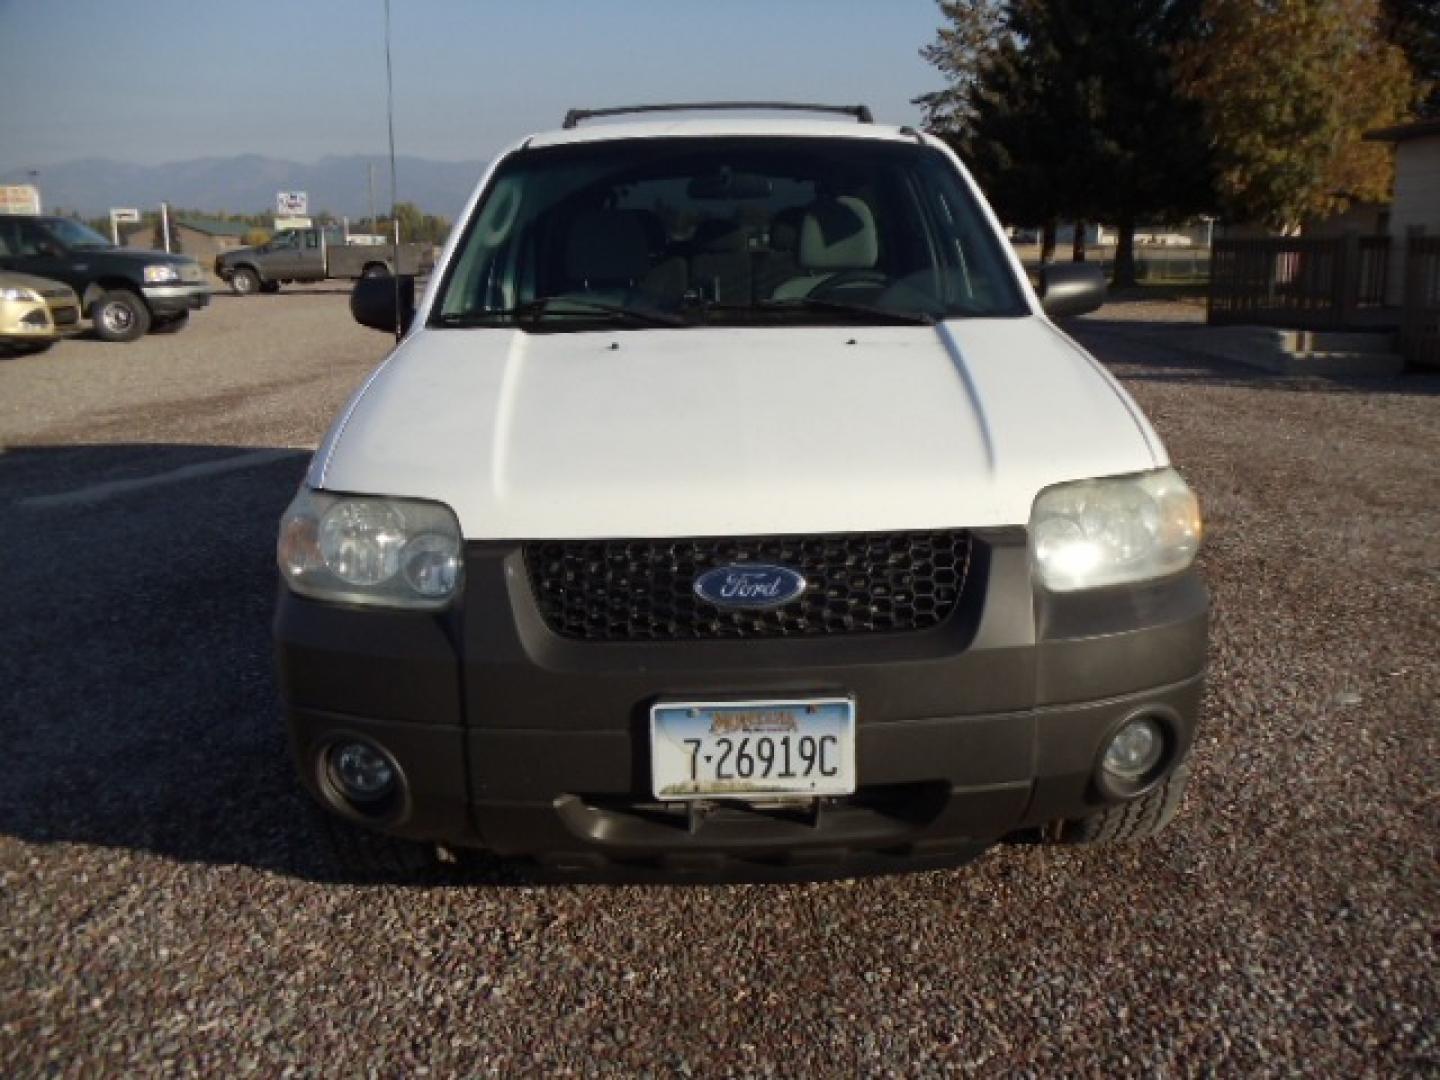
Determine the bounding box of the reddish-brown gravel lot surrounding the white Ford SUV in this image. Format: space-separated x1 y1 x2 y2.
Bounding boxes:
0 289 1440 1076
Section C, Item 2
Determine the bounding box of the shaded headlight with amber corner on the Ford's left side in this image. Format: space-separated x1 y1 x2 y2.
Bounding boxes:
276 487 464 611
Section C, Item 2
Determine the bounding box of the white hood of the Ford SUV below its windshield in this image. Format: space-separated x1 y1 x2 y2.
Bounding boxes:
310 317 1165 539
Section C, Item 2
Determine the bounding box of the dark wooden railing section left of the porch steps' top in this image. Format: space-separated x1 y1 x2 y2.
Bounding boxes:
1208 236 1390 330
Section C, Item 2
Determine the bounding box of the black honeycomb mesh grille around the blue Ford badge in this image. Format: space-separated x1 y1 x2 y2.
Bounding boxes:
526 530 971 641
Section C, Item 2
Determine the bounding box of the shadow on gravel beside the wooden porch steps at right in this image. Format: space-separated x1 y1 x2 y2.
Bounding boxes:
1063 315 1440 397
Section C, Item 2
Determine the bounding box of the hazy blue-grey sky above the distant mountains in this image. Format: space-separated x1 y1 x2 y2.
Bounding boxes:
0 0 939 173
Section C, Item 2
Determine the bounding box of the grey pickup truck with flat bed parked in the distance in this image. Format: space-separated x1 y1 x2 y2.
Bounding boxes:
215 229 431 297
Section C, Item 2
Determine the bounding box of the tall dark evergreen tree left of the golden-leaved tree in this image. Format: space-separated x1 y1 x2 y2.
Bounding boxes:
922 0 1210 285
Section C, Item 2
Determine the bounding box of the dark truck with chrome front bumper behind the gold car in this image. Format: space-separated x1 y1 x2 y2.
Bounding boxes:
0 215 210 341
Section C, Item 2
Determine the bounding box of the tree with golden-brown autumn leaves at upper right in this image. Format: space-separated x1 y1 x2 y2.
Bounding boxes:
1175 0 1413 230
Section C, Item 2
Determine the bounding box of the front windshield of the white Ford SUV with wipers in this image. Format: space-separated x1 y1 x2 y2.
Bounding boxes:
431 137 1028 333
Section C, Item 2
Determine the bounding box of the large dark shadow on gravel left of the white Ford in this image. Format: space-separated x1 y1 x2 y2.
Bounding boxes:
0 445 517 883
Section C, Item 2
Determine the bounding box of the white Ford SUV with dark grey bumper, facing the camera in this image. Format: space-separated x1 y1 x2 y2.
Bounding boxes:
275 107 1208 880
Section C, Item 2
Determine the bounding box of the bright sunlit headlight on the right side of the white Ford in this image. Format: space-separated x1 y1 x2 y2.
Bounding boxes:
1030 469 1200 592
